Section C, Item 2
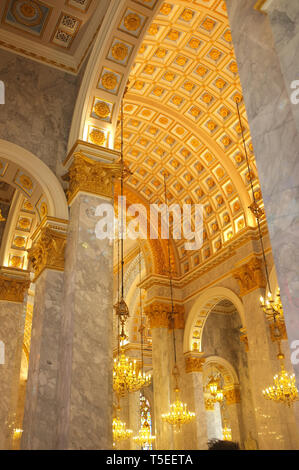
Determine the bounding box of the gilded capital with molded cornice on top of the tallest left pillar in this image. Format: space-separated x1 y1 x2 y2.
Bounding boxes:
63 141 121 205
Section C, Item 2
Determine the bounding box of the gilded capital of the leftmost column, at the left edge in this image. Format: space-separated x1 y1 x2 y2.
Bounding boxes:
0 267 30 303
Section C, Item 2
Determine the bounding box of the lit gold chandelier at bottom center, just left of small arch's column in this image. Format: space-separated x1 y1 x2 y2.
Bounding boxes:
162 363 195 431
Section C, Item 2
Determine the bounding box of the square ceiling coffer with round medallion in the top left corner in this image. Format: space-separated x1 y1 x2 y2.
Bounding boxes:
2 0 52 36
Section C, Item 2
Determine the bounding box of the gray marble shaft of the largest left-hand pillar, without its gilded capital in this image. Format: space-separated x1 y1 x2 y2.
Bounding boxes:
57 193 113 450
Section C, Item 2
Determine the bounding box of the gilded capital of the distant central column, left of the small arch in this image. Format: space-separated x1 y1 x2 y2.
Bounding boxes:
145 301 185 330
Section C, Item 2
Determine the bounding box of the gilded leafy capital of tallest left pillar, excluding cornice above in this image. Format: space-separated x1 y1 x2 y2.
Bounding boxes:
63 151 121 204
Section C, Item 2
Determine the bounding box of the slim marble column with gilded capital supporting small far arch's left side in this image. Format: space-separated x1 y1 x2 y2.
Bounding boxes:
183 351 208 450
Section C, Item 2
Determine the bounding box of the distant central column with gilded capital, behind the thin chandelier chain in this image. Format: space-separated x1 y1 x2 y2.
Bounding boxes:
145 301 174 450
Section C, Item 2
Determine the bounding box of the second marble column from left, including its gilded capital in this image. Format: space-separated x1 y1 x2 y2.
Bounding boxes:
21 217 67 450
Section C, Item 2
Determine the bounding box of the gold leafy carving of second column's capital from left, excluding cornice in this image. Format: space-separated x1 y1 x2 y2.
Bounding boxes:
28 226 66 279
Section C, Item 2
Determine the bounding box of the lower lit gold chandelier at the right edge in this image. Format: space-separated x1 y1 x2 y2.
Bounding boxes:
263 341 299 407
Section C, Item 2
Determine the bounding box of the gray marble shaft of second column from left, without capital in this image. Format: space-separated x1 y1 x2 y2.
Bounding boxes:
21 269 63 450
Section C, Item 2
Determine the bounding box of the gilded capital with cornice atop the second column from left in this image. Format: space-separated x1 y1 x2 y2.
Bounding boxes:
28 217 67 280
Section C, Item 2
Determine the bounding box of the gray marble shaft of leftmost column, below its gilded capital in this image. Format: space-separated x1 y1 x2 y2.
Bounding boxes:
0 300 25 450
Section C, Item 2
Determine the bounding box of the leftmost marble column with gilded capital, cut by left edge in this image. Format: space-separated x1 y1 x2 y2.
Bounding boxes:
0 268 30 450
